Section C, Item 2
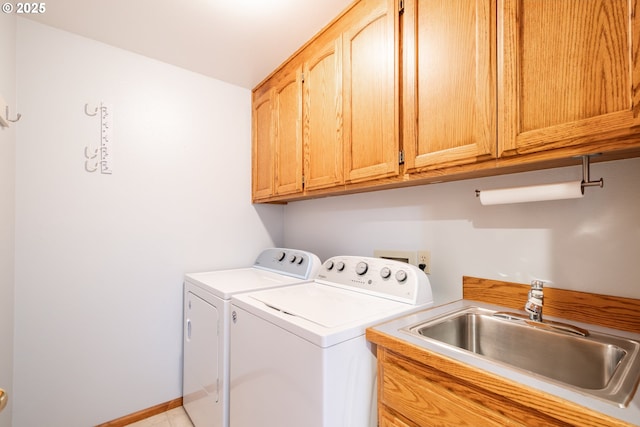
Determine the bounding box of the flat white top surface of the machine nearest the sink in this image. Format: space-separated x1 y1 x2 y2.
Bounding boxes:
250 283 412 329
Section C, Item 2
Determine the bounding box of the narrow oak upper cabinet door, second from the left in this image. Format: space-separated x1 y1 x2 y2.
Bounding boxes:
274 67 302 195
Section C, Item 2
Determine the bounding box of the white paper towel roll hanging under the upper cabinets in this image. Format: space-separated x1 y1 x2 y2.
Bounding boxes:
480 181 583 205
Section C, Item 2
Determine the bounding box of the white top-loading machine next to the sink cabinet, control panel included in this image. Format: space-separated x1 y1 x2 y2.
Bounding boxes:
229 256 433 427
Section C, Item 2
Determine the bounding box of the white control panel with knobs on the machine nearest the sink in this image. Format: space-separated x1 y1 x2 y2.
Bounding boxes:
317 256 433 305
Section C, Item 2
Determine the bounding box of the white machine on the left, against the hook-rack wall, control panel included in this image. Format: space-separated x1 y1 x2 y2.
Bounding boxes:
182 248 321 427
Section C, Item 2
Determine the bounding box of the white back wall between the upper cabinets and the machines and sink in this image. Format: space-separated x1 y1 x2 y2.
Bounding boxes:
285 159 640 302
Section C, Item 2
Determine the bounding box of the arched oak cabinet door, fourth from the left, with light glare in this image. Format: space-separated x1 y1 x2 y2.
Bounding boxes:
343 0 399 182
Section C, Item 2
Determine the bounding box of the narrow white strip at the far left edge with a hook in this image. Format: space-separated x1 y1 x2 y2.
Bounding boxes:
0 13 16 427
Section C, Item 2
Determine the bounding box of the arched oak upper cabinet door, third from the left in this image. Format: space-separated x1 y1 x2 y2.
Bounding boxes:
304 37 344 190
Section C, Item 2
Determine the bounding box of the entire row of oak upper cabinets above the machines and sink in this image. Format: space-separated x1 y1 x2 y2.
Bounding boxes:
252 0 640 202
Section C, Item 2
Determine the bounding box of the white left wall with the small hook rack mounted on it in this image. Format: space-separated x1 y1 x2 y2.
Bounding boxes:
13 19 283 427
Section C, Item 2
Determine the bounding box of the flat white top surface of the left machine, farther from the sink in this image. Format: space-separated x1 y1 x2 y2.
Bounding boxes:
185 267 305 299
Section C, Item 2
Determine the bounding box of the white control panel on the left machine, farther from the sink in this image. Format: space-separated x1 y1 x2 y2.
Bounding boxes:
253 248 321 280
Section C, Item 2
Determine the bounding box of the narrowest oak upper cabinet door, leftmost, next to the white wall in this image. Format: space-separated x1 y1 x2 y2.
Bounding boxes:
251 89 275 201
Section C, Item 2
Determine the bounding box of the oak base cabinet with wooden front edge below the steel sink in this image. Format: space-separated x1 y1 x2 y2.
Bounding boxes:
367 329 632 427
